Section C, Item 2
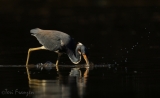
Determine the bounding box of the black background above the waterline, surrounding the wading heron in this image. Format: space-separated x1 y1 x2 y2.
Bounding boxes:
0 0 160 66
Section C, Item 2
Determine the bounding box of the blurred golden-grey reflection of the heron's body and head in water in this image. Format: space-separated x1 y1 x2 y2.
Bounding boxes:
29 64 89 98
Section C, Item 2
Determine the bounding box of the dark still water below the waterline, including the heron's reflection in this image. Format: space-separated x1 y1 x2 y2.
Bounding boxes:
0 64 160 98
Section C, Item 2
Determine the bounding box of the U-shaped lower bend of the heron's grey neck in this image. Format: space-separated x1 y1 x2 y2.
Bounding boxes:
67 49 81 64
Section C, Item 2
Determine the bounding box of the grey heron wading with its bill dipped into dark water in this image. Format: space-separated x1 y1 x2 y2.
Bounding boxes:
26 28 89 71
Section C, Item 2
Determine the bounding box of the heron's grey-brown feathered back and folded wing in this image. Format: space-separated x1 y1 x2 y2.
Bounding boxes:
30 29 74 51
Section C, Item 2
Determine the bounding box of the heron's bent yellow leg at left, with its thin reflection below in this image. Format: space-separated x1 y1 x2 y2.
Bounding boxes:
26 46 46 81
